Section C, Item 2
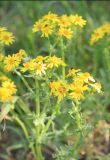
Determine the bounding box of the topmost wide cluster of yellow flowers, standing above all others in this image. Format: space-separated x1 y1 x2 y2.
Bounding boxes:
32 12 86 39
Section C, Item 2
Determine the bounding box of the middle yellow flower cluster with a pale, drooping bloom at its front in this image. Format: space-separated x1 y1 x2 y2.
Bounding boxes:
21 56 66 76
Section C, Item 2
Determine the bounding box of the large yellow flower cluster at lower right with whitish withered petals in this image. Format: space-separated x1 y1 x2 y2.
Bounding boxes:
50 69 101 101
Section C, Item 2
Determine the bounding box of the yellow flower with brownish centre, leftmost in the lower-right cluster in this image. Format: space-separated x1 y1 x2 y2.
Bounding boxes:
50 81 68 102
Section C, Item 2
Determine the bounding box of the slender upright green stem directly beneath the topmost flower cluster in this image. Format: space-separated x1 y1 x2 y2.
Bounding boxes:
61 39 65 79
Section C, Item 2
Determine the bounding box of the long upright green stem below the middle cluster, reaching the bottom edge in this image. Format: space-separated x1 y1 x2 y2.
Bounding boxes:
35 80 43 160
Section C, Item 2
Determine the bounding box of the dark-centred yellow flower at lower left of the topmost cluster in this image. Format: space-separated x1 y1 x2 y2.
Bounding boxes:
41 25 53 37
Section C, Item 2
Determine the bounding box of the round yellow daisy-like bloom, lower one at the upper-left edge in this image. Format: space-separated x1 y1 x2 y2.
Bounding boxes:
0 31 14 45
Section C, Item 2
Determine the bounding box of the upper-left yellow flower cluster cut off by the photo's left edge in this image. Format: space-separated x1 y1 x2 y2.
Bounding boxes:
0 27 15 45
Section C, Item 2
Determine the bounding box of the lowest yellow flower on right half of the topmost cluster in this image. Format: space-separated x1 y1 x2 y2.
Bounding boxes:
57 27 73 39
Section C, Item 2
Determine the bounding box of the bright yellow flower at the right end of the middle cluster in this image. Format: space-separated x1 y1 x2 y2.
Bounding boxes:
46 56 66 68
